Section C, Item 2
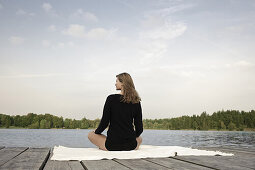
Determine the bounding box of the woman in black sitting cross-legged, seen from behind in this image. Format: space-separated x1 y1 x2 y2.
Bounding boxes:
88 73 143 151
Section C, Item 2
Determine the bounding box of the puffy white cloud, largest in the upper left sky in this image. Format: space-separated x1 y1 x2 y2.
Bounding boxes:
62 24 118 40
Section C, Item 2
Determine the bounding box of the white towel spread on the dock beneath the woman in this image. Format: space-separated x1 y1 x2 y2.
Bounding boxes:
50 145 234 161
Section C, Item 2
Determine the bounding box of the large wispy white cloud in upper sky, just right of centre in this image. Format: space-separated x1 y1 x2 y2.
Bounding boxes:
138 15 187 65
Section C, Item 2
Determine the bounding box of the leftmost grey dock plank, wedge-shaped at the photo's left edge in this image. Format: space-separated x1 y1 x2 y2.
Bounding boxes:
0 147 28 167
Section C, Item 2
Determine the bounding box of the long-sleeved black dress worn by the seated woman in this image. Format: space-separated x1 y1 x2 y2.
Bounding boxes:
95 94 143 151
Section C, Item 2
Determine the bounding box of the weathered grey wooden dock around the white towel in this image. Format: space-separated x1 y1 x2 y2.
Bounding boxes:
0 146 255 170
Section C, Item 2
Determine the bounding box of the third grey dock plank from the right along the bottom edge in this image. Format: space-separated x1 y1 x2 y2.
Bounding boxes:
113 159 170 170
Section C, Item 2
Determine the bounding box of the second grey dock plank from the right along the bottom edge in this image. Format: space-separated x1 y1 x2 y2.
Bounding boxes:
143 157 211 170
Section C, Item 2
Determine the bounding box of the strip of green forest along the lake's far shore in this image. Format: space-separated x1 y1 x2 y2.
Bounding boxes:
0 110 255 131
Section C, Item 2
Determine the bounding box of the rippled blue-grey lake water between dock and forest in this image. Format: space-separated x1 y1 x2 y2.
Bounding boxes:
0 129 255 149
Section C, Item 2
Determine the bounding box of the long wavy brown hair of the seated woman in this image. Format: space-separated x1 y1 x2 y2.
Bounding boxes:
116 72 141 104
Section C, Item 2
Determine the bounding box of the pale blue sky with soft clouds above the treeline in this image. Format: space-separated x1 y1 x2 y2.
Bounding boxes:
0 0 255 120
